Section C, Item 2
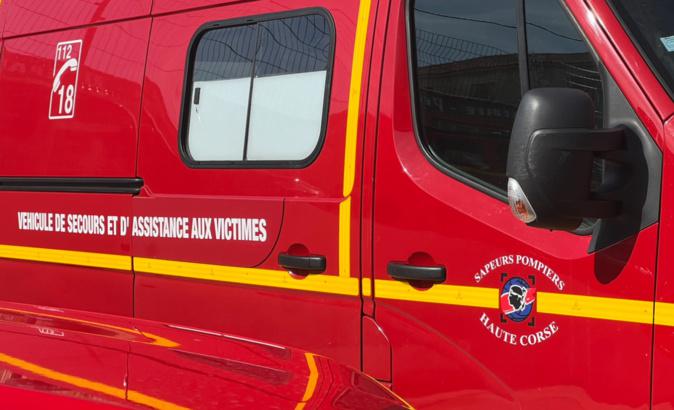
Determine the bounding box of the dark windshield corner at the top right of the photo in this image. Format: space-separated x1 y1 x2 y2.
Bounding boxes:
609 0 674 96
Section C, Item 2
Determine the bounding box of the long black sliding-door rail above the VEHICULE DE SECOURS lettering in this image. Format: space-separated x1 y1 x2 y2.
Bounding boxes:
0 177 144 195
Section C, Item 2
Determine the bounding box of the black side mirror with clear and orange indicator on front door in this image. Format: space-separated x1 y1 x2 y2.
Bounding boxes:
507 88 625 231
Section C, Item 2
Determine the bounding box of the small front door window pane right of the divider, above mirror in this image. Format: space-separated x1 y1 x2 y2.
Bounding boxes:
525 0 603 127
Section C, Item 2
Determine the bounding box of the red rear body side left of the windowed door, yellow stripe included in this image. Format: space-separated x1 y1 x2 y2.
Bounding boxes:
0 4 150 315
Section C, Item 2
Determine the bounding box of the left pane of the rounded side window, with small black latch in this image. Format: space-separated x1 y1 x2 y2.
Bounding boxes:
188 26 256 161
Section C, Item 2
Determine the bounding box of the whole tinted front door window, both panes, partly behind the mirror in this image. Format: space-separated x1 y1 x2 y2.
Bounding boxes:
411 0 603 193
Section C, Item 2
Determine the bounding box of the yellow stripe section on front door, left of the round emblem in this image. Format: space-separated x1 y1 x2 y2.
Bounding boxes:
374 280 499 309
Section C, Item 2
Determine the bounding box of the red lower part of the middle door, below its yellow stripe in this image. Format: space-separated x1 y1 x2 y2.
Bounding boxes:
136 274 360 367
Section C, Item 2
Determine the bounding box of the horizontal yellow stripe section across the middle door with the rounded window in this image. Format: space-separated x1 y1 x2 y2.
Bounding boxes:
133 258 360 296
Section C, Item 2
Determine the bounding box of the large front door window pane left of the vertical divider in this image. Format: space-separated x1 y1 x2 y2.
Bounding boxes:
412 0 521 190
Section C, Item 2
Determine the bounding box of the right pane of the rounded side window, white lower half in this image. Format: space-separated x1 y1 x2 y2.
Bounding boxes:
247 15 330 161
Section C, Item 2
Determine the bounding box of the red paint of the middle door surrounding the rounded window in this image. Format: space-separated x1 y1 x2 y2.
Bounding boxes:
132 0 361 366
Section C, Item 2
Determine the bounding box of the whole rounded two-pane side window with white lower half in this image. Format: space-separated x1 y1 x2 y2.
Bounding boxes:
183 15 333 165
